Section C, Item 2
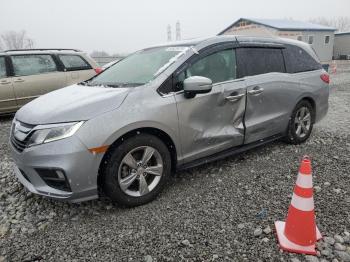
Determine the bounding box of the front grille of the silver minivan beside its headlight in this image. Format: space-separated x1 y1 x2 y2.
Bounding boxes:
10 120 34 152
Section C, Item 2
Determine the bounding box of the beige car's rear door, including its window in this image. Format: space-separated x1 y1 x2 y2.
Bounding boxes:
11 54 66 106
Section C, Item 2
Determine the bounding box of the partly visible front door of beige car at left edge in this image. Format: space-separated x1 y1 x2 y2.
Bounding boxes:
0 56 17 114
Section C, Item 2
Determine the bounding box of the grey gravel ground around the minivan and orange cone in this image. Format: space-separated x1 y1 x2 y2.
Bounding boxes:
0 64 350 262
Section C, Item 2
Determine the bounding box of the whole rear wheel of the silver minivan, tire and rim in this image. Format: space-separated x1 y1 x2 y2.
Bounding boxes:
285 100 315 145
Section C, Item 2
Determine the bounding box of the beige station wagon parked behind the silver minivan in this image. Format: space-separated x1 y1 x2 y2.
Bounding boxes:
0 49 100 114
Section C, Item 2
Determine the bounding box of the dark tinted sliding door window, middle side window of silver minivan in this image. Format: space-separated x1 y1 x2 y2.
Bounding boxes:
237 47 285 77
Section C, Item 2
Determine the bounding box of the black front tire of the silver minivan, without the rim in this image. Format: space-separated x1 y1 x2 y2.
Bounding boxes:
102 134 171 207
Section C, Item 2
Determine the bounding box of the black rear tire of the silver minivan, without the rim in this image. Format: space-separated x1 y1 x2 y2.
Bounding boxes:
284 100 315 145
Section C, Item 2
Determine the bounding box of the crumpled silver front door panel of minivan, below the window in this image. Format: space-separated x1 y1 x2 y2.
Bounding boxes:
175 80 246 162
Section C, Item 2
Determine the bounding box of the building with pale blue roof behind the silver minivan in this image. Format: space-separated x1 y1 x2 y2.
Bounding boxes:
219 18 336 63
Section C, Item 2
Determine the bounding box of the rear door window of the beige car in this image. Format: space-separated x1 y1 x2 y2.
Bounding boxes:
11 55 57 76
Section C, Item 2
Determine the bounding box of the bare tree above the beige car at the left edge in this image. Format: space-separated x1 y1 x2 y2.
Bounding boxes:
0 30 34 49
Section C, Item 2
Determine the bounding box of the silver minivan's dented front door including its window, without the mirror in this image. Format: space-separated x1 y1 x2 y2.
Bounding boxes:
174 47 246 162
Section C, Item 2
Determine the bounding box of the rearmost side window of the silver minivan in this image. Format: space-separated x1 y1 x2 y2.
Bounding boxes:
283 45 322 73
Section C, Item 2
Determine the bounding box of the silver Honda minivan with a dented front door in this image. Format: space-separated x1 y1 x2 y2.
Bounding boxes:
10 36 329 206
